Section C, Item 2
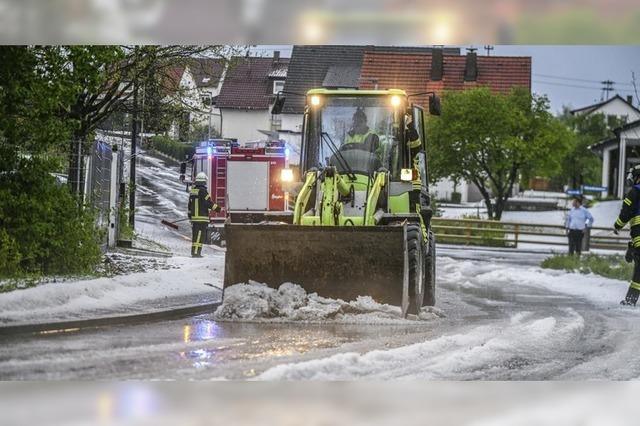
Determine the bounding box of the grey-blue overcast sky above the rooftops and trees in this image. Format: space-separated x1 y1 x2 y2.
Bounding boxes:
254 45 640 112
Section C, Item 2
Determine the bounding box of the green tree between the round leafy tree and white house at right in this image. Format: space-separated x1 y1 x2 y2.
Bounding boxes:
556 107 624 188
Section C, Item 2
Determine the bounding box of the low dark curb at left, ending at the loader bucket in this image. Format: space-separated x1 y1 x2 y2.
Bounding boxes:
0 302 222 337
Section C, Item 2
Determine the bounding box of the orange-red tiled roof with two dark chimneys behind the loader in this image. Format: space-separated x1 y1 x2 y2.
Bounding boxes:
360 52 531 105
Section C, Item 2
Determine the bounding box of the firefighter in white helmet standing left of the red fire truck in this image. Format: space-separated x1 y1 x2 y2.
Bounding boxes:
188 172 220 257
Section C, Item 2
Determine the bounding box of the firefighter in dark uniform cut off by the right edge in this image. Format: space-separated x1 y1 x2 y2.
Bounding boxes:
613 165 640 306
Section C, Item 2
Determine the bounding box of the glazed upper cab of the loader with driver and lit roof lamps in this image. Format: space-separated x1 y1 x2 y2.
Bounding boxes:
301 89 432 181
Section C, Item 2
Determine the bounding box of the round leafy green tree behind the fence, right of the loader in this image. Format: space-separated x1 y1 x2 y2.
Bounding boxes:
427 87 568 220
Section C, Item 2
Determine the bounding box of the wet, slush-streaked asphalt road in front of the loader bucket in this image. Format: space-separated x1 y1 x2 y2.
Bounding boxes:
0 262 640 380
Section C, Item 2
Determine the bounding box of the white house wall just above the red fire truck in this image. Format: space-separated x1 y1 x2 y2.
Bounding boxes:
221 108 271 143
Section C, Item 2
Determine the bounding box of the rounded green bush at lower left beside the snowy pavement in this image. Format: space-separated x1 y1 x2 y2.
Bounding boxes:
0 159 101 277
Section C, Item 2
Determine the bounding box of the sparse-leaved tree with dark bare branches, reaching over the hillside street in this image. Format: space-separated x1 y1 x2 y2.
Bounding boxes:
58 45 235 192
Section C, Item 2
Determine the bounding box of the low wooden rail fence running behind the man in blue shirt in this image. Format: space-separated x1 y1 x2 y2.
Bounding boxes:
432 218 629 251
